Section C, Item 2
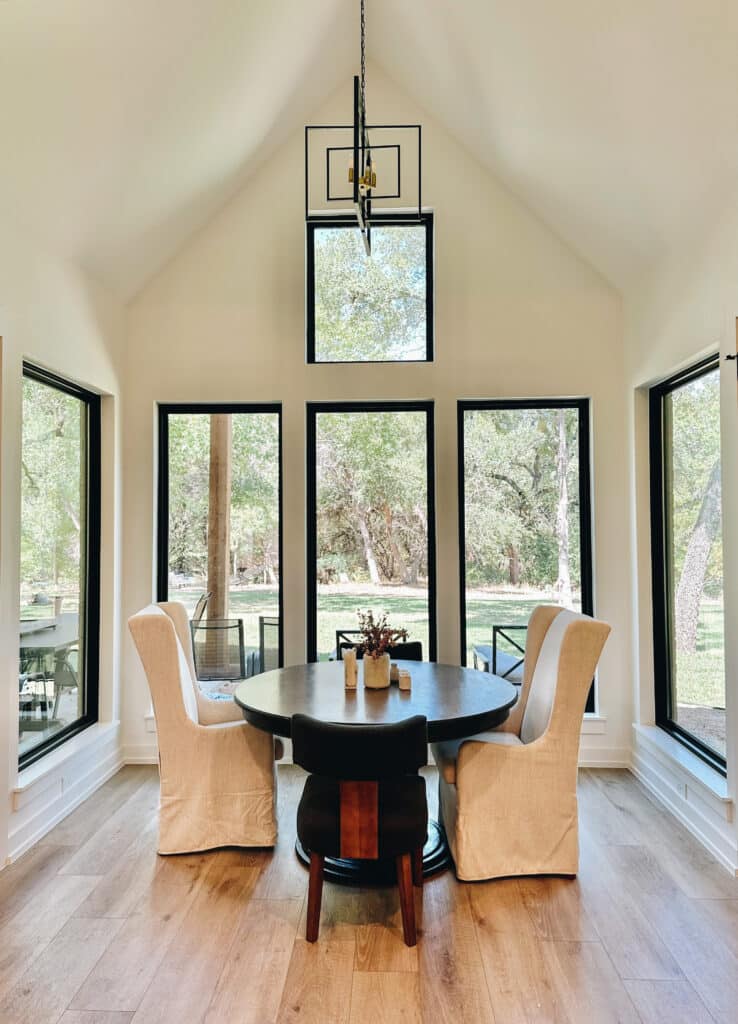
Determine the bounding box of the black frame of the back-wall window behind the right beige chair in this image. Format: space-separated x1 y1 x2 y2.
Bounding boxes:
457 398 597 715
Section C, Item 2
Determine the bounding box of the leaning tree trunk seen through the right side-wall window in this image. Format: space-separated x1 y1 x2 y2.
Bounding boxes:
675 460 721 654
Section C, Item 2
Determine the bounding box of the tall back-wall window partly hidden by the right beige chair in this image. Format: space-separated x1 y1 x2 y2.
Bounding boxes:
459 398 595 711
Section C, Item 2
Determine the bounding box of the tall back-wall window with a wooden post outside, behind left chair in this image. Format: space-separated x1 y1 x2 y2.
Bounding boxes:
158 404 284 689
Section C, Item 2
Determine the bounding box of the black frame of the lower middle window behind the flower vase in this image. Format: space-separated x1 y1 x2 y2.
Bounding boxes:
306 400 438 662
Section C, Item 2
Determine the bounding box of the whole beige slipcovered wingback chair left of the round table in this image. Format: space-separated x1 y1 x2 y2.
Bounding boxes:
128 601 278 854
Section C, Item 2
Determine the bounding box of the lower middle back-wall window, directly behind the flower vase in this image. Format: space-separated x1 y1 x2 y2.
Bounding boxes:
307 402 436 662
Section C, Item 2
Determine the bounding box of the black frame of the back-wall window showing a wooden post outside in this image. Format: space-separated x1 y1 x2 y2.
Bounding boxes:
157 401 285 669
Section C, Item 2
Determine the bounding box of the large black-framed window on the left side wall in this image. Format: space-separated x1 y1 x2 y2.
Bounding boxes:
18 365 100 767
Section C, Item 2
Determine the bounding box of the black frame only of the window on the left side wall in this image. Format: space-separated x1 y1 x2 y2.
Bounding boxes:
18 360 102 770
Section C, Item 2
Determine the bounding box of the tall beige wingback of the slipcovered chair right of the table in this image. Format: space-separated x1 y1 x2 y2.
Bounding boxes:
520 608 610 745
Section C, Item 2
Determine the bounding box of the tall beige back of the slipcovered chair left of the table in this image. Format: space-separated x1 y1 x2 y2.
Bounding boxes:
128 602 199 749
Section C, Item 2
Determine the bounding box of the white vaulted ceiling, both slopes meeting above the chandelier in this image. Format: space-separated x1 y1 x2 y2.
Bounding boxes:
0 0 738 295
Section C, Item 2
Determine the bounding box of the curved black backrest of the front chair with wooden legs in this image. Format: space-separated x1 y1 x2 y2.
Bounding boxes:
291 715 428 782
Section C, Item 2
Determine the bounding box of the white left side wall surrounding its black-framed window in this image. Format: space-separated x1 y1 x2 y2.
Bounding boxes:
0 222 124 866
